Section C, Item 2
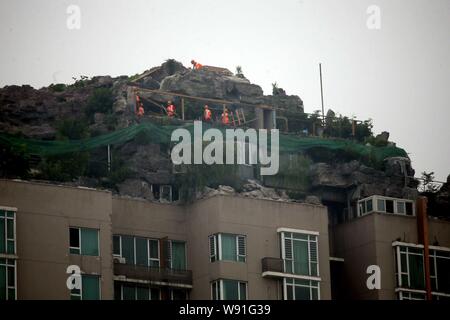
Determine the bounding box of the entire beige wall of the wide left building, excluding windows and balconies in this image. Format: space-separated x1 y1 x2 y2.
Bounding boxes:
0 180 331 299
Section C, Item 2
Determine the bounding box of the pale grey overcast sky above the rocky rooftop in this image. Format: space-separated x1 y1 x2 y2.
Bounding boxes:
0 0 450 181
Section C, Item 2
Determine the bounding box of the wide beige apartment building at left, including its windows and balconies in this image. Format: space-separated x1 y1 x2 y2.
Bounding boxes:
0 180 331 300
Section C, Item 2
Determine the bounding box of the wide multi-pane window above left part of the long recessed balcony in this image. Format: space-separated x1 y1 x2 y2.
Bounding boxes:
113 235 160 267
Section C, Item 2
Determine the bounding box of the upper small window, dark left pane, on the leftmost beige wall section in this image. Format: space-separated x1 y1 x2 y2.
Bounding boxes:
69 227 99 256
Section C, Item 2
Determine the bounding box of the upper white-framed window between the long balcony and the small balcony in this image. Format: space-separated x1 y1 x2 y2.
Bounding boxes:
209 233 247 262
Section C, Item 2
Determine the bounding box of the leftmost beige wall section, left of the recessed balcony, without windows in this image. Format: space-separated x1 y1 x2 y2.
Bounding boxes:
0 180 113 299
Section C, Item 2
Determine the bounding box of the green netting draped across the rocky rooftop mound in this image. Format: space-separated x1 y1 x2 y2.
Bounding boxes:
0 122 407 161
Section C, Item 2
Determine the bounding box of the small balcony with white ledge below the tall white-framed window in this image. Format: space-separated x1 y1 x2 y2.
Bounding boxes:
261 257 321 281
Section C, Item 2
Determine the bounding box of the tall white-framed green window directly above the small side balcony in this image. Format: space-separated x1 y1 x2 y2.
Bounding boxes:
281 232 319 277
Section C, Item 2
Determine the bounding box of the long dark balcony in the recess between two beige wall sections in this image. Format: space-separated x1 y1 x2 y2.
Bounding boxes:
114 262 192 288
